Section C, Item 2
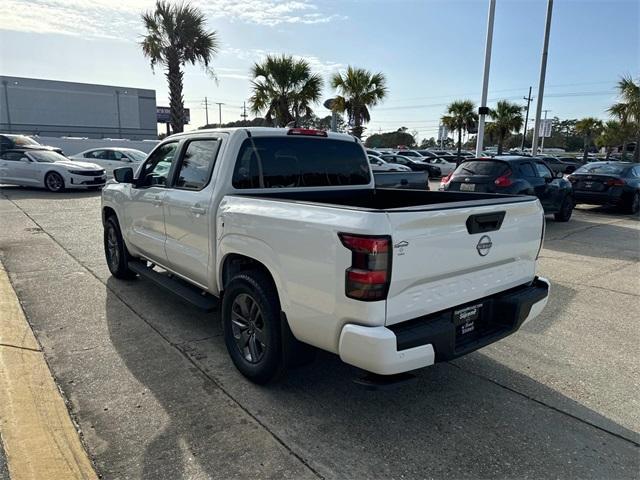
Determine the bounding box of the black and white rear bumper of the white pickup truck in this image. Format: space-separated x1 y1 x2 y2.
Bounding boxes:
338 277 550 375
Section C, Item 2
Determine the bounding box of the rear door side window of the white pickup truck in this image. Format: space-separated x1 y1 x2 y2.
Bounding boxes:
175 139 220 190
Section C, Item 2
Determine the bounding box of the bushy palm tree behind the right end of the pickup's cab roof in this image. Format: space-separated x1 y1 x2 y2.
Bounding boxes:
331 66 387 138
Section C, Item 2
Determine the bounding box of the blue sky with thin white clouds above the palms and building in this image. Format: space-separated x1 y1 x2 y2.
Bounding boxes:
0 0 640 138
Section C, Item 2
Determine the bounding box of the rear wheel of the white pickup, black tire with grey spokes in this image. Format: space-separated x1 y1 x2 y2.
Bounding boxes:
222 270 285 384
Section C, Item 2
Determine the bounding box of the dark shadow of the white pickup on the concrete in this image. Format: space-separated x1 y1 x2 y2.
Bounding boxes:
105 279 640 478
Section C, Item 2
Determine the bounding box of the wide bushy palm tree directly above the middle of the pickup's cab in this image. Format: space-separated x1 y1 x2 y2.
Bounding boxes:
249 55 322 127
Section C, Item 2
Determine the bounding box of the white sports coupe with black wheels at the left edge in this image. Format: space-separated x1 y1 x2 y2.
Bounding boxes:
0 149 107 192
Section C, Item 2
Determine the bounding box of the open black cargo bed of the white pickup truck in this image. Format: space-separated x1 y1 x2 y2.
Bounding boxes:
245 188 535 211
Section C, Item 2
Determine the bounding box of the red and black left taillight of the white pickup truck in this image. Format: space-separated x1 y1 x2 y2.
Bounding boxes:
338 233 391 301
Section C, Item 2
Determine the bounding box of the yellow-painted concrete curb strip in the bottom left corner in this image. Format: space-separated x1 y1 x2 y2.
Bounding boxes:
0 264 98 480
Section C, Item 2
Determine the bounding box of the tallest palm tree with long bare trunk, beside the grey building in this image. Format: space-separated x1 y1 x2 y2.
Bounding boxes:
141 0 218 132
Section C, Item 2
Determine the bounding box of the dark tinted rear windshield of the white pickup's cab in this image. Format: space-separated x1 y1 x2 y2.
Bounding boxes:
232 137 371 189
